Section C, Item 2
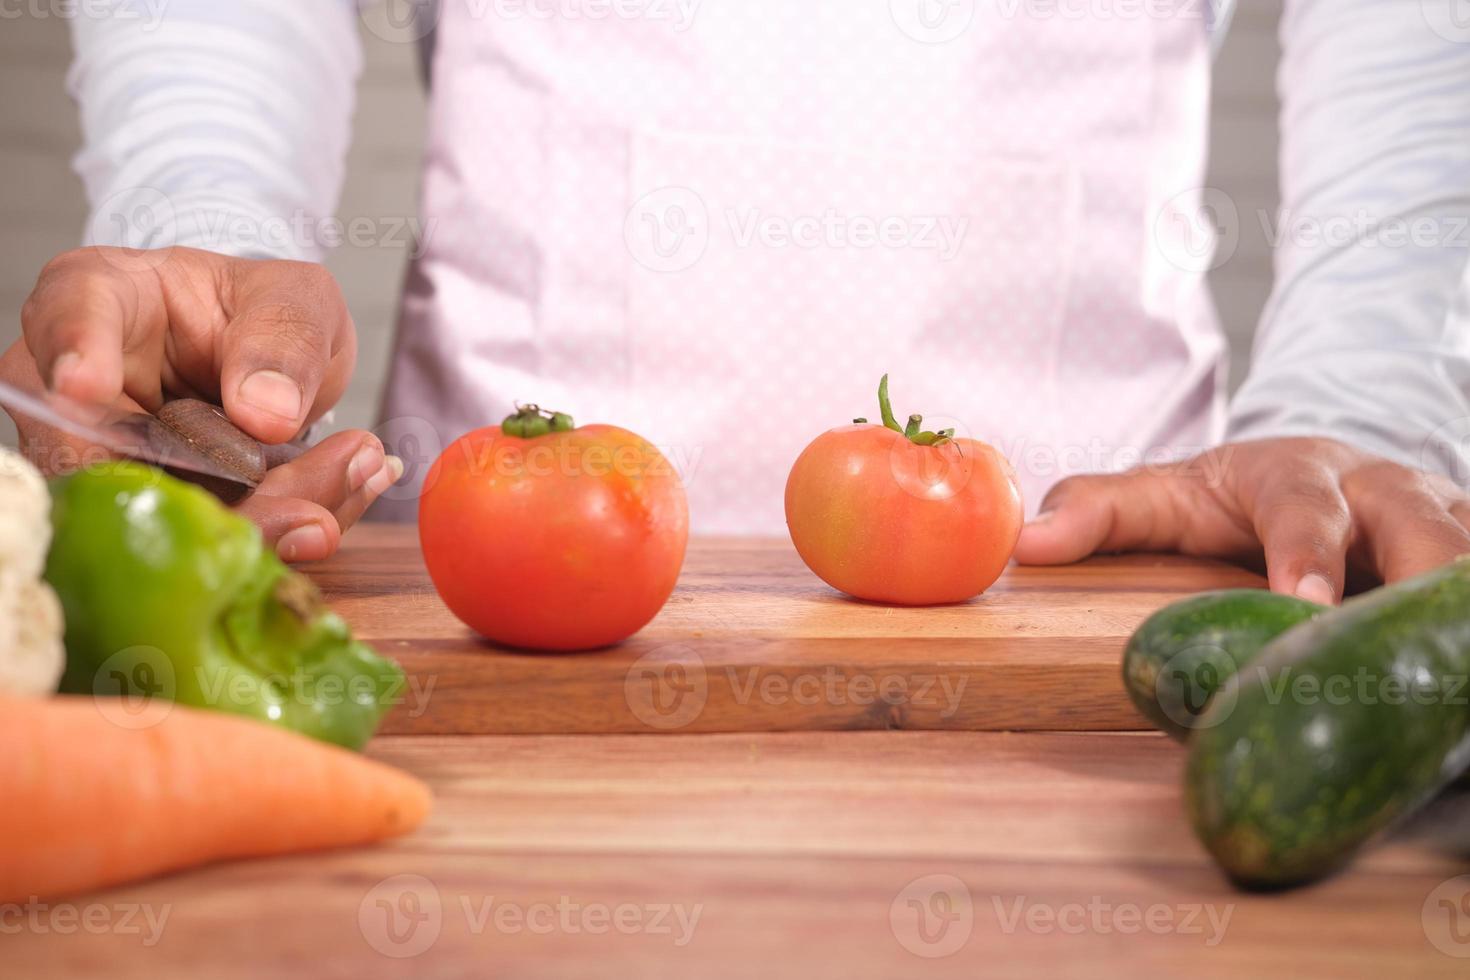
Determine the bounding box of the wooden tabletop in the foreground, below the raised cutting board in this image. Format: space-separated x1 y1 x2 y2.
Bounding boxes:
0 732 1470 980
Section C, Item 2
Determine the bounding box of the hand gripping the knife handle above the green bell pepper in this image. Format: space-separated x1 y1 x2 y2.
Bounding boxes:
0 247 403 561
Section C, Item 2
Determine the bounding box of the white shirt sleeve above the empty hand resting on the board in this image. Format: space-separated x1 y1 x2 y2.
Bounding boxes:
1229 0 1470 479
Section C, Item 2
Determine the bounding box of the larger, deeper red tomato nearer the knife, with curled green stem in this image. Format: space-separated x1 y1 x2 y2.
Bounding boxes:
419 407 689 649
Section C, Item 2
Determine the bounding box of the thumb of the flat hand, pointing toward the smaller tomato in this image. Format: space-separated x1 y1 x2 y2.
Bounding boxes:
1016 473 1179 564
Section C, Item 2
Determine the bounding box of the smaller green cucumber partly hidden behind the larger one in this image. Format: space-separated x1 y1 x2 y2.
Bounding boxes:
1123 589 1324 741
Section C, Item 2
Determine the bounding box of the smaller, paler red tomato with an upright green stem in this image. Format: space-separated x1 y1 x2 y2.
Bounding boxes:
786 379 1023 605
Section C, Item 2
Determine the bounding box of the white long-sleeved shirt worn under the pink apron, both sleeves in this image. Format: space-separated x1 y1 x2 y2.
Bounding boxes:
69 0 1470 482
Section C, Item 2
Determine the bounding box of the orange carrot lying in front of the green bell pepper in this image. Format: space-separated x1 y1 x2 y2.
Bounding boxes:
0 698 429 902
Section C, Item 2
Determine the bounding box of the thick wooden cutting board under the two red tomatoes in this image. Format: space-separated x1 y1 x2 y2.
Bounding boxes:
318 525 1263 735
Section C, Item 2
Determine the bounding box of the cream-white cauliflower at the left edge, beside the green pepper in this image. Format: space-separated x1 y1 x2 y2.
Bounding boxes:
0 447 66 695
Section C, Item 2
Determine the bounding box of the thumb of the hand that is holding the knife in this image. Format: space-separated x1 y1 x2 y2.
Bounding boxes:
219 262 356 442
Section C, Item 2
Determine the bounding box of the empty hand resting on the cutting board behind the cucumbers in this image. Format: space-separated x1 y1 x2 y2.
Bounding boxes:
1016 439 1470 604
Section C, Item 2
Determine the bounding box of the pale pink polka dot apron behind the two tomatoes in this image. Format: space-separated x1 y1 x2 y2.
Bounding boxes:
373 0 1223 533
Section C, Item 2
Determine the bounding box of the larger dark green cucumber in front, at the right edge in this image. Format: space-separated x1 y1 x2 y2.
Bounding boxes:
1185 558 1470 887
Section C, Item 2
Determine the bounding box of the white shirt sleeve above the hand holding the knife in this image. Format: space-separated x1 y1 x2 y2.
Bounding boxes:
68 0 362 262
